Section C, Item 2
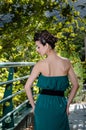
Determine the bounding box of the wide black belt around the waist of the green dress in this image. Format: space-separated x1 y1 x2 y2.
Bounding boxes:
40 89 64 97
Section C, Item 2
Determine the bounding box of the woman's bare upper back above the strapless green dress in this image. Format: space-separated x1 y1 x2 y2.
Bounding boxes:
41 55 70 76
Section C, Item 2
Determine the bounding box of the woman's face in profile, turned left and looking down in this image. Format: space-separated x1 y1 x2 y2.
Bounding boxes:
36 41 47 56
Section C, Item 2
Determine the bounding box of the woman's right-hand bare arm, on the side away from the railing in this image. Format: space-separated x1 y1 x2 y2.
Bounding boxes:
67 64 79 114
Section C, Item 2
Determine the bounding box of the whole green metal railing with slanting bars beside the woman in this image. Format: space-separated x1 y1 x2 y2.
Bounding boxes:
0 62 35 130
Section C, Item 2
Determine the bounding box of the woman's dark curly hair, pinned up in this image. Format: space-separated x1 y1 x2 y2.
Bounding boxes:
34 30 58 49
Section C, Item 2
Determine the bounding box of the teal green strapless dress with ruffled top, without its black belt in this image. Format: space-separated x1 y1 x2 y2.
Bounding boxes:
34 74 70 130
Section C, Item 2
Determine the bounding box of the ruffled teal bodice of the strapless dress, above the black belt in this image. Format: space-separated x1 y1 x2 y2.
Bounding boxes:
37 74 69 91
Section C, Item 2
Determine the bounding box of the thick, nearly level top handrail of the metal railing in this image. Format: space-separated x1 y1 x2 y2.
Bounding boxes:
0 62 35 68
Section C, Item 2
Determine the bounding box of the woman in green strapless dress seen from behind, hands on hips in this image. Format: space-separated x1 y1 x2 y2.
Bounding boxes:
25 30 78 130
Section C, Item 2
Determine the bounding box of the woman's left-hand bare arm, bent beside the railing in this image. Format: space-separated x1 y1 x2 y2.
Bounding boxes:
25 63 40 110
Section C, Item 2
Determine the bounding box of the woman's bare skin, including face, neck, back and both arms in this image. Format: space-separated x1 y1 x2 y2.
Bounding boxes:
25 41 79 114
